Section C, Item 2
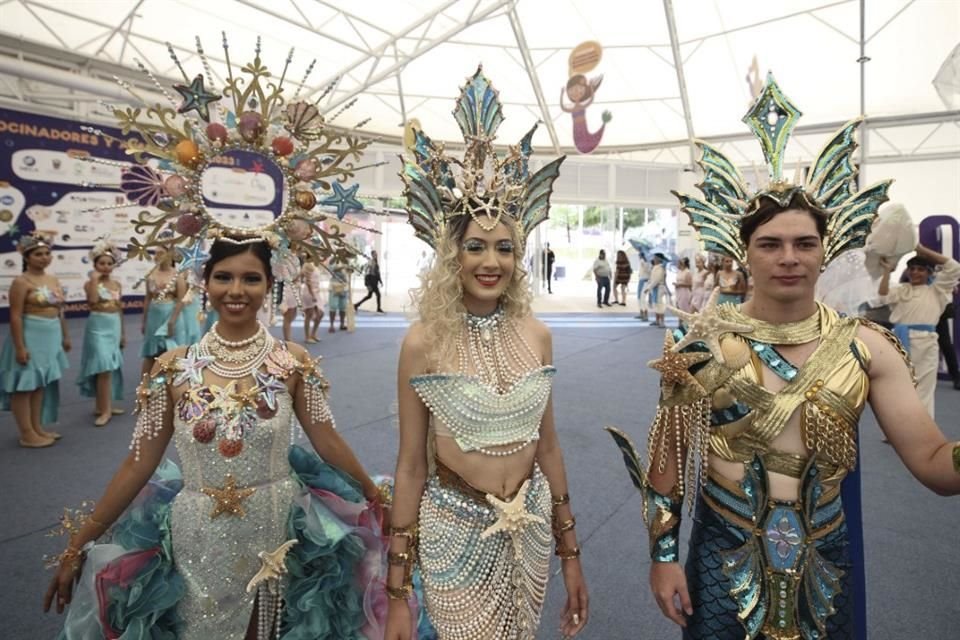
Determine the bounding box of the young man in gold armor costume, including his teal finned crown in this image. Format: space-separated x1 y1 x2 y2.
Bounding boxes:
611 72 960 640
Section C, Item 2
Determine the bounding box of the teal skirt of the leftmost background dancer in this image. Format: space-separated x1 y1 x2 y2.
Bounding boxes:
0 314 69 424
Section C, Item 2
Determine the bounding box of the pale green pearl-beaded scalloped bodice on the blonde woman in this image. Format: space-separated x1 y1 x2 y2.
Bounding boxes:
410 366 557 455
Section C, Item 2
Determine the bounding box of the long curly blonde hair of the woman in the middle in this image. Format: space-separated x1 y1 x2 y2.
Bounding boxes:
410 215 533 371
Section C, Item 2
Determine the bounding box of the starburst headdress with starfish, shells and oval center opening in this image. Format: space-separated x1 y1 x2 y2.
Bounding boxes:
81 34 382 288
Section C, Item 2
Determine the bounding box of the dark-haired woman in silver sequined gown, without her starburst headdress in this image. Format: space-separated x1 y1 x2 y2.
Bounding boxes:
45 238 382 640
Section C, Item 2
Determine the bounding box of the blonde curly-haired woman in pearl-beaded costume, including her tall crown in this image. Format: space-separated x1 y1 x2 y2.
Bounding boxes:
386 70 588 640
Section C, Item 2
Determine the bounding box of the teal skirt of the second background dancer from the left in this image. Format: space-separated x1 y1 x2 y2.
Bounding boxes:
77 311 123 402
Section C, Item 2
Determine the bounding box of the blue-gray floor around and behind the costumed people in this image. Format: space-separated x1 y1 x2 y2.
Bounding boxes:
0 314 960 640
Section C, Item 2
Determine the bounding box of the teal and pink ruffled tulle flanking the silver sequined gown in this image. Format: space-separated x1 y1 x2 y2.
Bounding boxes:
59 446 435 640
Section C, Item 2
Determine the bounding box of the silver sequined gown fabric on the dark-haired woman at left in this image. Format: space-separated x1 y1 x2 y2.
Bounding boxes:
171 393 295 640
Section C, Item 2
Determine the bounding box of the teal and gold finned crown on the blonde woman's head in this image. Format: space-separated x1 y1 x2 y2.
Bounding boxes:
400 67 566 248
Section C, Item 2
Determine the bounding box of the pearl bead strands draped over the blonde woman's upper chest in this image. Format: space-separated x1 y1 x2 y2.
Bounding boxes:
457 306 540 393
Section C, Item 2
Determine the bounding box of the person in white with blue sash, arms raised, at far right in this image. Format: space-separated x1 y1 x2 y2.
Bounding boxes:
877 244 960 418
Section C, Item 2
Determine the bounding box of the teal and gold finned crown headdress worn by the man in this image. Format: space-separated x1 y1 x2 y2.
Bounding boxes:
672 74 893 265
